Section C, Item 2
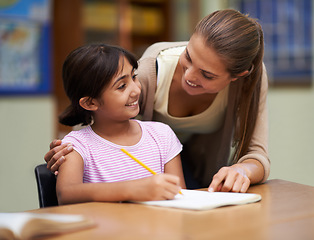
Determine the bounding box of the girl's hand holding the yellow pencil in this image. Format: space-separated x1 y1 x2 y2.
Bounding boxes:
130 173 181 201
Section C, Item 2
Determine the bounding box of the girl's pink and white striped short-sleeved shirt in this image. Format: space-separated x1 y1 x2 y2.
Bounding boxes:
62 120 182 182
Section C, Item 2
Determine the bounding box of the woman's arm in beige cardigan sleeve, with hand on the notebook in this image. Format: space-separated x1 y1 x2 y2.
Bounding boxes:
208 64 270 192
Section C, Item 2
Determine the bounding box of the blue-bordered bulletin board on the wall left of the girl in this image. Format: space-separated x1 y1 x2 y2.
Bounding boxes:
0 0 52 96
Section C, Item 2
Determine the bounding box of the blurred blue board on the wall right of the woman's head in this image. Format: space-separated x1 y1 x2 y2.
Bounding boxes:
236 0 313 86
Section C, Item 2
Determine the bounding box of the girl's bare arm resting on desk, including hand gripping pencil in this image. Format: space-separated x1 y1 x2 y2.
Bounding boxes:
56 151 181 204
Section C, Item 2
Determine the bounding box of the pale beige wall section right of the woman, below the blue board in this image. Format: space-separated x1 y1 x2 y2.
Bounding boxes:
268 87 314 186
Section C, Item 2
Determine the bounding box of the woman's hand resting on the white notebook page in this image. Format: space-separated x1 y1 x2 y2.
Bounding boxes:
208 163 251 193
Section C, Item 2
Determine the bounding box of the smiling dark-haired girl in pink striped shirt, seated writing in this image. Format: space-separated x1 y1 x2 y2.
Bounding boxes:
56 44 185 204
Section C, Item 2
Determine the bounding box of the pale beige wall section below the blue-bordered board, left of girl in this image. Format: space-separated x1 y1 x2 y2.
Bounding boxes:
0 97 56 212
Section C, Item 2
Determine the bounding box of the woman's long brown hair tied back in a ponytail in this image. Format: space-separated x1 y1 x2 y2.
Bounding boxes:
195 9 264 162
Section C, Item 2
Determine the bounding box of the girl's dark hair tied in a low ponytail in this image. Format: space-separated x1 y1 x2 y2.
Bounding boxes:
59 44 138 126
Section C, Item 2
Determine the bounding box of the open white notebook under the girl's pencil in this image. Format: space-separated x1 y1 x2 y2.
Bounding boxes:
138 189 262 210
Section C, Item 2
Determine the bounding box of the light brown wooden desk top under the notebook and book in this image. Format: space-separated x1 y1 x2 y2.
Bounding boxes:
32 180 314 240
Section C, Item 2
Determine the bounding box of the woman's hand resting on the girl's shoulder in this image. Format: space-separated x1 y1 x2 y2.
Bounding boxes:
44 139 73 175
